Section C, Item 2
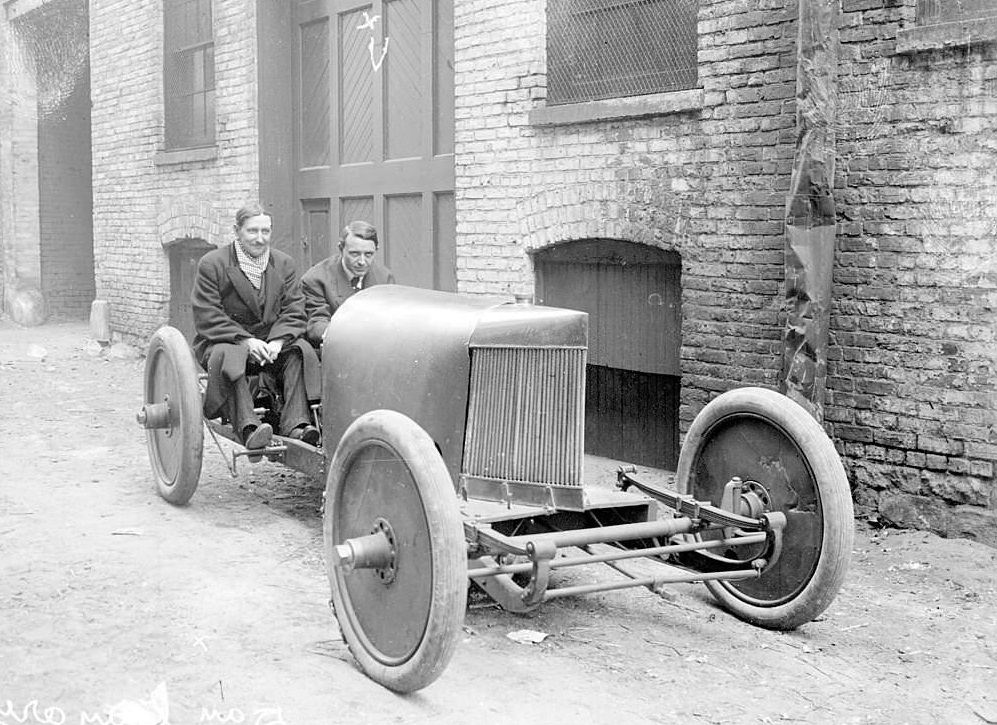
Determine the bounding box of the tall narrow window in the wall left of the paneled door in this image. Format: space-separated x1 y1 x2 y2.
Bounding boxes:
163 0 215 150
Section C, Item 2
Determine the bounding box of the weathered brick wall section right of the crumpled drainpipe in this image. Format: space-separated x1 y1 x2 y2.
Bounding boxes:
827 0 997 543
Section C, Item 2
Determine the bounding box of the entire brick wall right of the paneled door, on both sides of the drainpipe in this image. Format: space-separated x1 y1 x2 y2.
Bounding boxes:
455 0 997 543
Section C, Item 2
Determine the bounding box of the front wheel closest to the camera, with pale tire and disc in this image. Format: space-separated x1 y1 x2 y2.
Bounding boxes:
323 410 467 693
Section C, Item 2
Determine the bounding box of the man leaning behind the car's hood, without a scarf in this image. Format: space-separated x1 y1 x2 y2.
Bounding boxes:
301 221 395 347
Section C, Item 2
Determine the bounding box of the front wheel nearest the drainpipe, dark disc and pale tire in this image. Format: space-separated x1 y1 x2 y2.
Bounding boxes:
675 388 854 630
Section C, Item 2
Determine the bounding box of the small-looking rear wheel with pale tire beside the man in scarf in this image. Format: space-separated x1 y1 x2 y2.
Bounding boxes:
144 326 204 506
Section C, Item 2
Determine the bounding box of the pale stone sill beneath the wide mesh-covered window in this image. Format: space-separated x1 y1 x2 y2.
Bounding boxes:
529 88 703 126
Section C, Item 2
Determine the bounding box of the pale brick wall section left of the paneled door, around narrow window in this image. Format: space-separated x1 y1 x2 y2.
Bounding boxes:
90 0 260 338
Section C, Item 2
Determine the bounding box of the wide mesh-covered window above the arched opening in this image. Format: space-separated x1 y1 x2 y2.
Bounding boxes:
547 0 699 105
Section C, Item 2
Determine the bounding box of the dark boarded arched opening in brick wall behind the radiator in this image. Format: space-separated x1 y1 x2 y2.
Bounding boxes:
533 239 682 470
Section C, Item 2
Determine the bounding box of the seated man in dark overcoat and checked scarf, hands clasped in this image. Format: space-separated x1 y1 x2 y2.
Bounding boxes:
190 199 320 449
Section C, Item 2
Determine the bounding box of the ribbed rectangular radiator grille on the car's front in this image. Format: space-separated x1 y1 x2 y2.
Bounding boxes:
464 347 586 487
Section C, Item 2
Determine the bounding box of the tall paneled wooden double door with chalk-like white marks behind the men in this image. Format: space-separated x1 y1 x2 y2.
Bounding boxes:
293 0 456 290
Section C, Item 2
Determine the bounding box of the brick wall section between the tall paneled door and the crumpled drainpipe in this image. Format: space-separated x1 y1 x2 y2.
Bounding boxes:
455 0 796 430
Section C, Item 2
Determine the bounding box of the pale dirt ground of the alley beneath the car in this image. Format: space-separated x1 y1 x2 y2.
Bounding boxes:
0 320 997 725
